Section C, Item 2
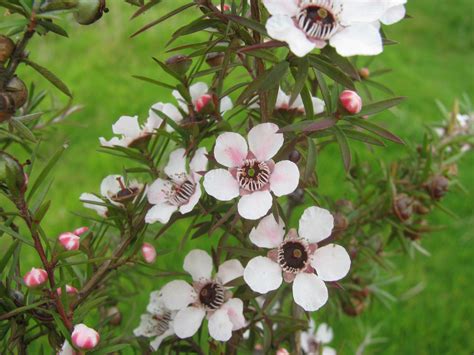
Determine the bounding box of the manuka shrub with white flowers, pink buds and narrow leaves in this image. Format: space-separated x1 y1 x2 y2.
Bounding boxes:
0 0 474 354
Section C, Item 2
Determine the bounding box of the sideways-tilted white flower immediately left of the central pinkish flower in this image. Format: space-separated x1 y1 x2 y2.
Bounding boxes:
145 148 207 223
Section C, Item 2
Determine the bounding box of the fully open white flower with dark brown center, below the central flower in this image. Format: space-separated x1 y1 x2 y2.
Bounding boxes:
244 206 351 311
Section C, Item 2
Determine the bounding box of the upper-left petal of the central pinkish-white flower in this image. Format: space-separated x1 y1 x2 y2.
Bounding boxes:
214 132 248 168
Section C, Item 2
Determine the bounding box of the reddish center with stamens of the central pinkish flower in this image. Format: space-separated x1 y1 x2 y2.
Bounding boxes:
236 159 270 192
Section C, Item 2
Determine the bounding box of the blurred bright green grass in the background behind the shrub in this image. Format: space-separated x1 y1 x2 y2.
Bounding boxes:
10 0 474 354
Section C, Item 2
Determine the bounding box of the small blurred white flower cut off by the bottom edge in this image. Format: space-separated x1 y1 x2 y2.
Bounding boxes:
300 319 336 355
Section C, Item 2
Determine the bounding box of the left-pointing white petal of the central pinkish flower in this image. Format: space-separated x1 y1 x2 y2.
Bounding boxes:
203 169 240 201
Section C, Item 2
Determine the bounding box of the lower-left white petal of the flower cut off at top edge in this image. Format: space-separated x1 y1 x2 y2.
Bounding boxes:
265 15 316 57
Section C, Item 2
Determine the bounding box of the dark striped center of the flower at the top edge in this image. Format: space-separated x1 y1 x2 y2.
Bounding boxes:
297 0 339 40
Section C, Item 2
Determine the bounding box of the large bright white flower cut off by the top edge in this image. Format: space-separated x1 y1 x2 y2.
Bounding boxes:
263 0 390 57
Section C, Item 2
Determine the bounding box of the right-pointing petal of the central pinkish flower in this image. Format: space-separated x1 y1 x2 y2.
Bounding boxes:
270 160 300 196
